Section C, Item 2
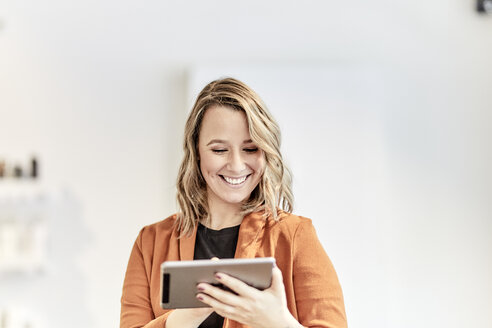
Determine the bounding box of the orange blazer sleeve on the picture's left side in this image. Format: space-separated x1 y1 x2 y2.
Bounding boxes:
120 229 172 328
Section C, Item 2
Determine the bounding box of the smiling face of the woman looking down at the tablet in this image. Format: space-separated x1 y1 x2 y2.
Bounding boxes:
198 106 265 206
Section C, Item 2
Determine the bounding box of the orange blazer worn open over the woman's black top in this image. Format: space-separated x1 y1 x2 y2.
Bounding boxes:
120 212 347 328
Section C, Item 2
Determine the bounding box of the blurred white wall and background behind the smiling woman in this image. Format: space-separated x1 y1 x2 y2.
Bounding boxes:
0 0 492 328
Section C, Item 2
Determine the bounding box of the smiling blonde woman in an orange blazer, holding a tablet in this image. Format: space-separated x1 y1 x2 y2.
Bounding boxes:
120 78 347 328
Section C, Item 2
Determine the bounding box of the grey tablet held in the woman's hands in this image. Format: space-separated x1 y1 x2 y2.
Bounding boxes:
161 257 275 309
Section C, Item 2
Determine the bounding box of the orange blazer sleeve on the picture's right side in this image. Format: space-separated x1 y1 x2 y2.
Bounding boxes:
293 219 347 328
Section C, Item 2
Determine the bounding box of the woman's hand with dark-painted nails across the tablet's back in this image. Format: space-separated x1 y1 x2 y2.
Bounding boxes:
197 267 300 328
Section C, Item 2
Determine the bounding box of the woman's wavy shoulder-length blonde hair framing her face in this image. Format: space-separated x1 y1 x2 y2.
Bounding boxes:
176 78 293 236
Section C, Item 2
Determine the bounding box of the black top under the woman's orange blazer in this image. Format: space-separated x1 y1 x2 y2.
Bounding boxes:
193 223 240 328
